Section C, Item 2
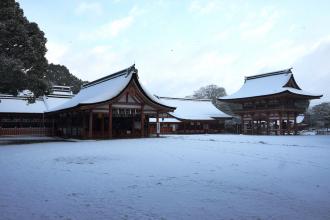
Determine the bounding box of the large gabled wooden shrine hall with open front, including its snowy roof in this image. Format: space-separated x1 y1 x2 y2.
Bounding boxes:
46 65 175 139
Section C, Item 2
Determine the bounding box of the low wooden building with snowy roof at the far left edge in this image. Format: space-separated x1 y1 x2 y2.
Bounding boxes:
0 85 73 136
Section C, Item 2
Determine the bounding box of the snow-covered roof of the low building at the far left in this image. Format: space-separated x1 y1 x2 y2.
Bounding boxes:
0 94 71 114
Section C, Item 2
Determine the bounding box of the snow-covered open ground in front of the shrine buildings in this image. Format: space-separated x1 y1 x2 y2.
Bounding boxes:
0 135 330 220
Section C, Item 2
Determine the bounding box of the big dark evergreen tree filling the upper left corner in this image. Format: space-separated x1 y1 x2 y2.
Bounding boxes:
0 0 49 97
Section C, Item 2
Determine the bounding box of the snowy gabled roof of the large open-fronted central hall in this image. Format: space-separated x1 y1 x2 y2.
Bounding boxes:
49 65 175 112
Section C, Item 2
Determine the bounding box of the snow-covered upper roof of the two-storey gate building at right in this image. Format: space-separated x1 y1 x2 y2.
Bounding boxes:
219 69 322 100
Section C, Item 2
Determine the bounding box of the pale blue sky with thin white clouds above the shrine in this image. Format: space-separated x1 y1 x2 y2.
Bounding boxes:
18 0 330 101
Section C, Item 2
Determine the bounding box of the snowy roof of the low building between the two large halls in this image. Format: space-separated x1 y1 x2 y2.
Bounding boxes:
159 97 231 120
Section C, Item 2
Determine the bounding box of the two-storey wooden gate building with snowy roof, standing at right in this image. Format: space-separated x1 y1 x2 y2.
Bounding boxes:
218 69 322 135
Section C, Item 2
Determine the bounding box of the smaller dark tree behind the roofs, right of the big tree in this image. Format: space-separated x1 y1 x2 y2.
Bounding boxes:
46 64 86 94
